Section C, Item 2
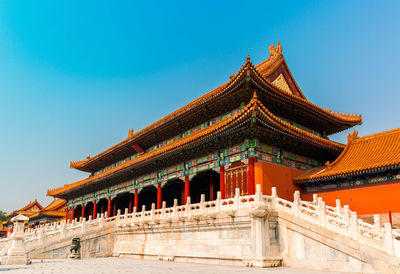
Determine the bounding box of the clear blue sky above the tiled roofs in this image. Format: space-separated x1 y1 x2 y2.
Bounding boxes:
0 0 400 211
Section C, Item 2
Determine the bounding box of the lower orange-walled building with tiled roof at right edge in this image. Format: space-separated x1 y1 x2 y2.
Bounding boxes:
295 128 400 224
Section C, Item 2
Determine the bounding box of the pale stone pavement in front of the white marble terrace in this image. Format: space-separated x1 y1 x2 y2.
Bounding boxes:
0 258 346 274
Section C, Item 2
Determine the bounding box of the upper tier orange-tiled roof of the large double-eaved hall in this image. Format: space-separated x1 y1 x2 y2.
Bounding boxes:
70 42 361 171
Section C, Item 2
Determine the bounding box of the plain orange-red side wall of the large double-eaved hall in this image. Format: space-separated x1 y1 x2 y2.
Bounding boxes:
254 161 304 201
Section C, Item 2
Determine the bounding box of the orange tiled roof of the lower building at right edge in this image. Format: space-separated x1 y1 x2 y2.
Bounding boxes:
295 128 400 183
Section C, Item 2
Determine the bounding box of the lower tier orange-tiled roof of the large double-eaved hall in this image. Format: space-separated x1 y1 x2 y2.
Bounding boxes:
47 93 344 197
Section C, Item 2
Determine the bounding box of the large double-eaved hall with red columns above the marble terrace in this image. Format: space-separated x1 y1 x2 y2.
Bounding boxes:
47 43 361 223
